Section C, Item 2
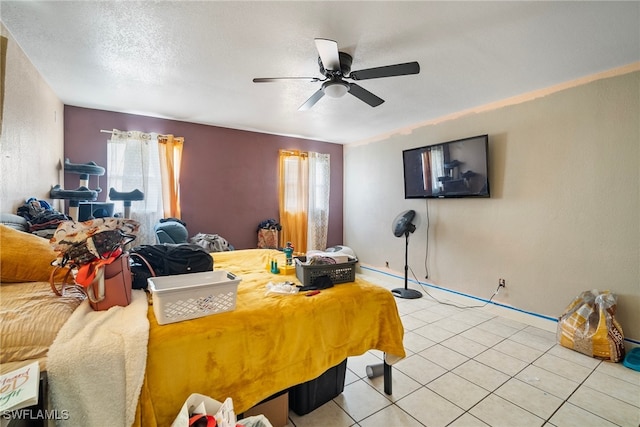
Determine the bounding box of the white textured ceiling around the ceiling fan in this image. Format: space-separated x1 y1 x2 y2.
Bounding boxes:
0 1 640 144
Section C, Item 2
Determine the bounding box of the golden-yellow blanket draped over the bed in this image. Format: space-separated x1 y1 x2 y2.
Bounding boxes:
136 249 405 426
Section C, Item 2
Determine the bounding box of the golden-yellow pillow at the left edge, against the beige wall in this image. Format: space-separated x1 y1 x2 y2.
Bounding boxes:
0 224 66 283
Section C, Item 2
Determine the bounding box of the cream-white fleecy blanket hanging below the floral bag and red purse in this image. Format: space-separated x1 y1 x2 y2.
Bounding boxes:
47 290 149 427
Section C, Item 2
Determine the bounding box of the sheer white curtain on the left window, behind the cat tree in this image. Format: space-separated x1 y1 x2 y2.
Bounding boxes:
107 129 163 245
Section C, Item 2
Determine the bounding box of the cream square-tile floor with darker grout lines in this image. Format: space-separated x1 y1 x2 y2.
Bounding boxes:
288 280 640 427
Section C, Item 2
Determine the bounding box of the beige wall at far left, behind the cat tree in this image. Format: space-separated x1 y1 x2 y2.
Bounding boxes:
0 23 64 213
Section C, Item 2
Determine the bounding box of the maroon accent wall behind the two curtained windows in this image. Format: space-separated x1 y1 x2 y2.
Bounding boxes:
64 106 343 249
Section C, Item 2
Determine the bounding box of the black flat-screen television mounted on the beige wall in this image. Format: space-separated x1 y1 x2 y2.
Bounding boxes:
402 135 490 199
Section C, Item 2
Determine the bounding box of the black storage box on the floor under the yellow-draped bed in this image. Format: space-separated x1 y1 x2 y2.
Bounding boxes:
289 359 347 415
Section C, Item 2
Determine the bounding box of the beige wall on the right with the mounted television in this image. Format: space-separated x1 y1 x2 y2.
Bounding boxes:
344 71 640 341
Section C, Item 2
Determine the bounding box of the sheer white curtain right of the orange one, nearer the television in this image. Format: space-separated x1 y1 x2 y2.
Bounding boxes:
307 152 331 250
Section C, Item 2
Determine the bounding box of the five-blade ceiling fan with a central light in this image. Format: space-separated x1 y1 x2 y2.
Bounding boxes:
253 39 420 111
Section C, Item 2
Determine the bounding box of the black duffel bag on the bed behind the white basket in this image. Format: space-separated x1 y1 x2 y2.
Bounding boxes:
129 243 213 289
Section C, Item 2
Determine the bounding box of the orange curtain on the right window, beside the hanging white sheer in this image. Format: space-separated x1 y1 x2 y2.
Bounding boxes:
278 150 309 252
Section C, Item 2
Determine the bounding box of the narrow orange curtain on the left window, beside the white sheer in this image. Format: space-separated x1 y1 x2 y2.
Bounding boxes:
158 135 184 219
